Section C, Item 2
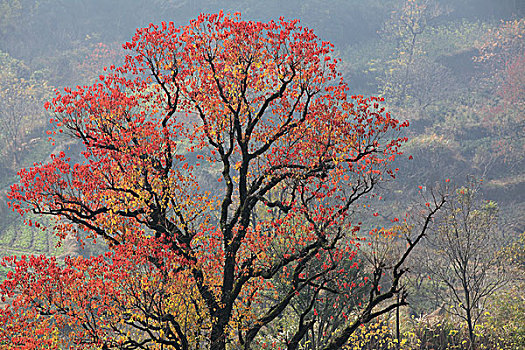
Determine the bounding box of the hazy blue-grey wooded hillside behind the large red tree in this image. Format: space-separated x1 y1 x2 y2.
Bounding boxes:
0 0 525 342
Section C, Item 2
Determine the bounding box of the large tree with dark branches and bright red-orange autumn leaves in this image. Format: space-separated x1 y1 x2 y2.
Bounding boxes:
0 14 443 349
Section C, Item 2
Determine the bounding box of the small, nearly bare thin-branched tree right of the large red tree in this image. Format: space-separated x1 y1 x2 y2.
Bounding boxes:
428 181 507 348
